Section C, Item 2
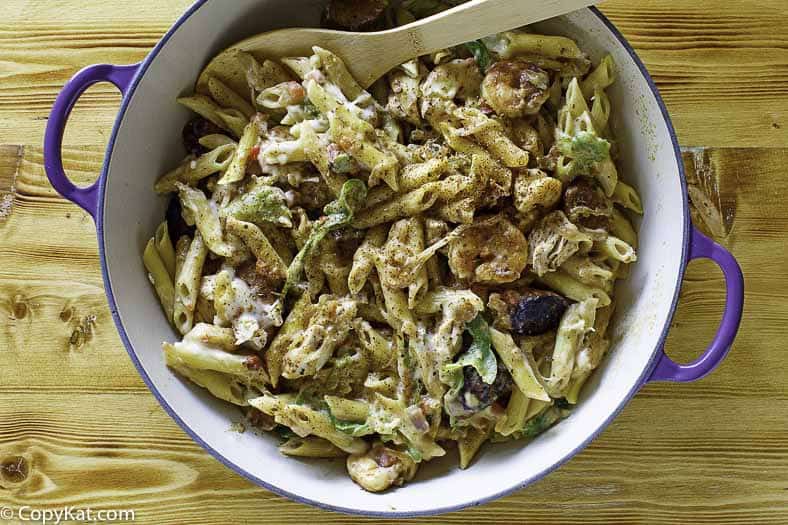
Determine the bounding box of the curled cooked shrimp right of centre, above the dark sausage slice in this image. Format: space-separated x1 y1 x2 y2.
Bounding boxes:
449 215 528 283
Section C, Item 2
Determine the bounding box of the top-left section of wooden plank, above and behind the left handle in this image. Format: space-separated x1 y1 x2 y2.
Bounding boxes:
0 0 192 145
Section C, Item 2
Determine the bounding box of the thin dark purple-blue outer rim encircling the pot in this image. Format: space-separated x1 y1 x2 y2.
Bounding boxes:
96 0 690 518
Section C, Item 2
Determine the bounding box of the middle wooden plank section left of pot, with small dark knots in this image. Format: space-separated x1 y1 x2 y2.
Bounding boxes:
0 146 145 392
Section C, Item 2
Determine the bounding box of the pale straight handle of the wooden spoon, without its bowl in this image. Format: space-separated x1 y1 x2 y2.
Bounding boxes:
391 0 600 60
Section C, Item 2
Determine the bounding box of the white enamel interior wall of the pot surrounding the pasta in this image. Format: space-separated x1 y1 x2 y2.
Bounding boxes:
103 0 687 513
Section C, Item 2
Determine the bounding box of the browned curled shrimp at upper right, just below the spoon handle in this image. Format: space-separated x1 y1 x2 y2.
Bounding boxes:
482 60 550 118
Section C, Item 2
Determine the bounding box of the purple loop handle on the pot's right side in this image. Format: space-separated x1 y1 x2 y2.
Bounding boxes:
646 226 744 383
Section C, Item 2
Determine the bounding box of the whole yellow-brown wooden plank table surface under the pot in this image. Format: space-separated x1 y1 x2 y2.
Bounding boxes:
0 0 788 524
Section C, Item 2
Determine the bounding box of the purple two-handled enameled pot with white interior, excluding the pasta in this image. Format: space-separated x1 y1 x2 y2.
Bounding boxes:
44 0 744 517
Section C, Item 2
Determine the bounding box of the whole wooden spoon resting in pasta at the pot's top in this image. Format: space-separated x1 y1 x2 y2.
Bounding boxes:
196 0 600 93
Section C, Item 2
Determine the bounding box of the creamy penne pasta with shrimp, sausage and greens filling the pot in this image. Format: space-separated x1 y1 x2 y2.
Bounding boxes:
143 2 642 491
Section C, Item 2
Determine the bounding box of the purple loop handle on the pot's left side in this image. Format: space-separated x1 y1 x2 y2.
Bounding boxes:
44 64 140 220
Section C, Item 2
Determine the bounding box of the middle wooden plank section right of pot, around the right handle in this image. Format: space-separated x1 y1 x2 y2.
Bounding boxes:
657 149 788 399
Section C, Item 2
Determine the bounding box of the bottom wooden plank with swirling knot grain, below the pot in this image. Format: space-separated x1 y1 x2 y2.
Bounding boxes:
0 387 788 524
